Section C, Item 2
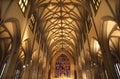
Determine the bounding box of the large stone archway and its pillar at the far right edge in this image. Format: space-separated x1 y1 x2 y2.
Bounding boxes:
99 16 119 79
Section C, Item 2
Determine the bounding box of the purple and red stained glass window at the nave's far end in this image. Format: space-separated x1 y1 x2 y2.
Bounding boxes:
55 54 70 78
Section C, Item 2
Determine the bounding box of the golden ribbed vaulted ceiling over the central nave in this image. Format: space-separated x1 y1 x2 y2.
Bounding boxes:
34 0 88 54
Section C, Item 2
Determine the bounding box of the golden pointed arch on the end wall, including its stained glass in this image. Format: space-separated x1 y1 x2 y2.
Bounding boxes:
50 51 75 79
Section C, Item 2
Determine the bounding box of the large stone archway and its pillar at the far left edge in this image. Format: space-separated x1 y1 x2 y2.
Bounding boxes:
0 18 21 78
